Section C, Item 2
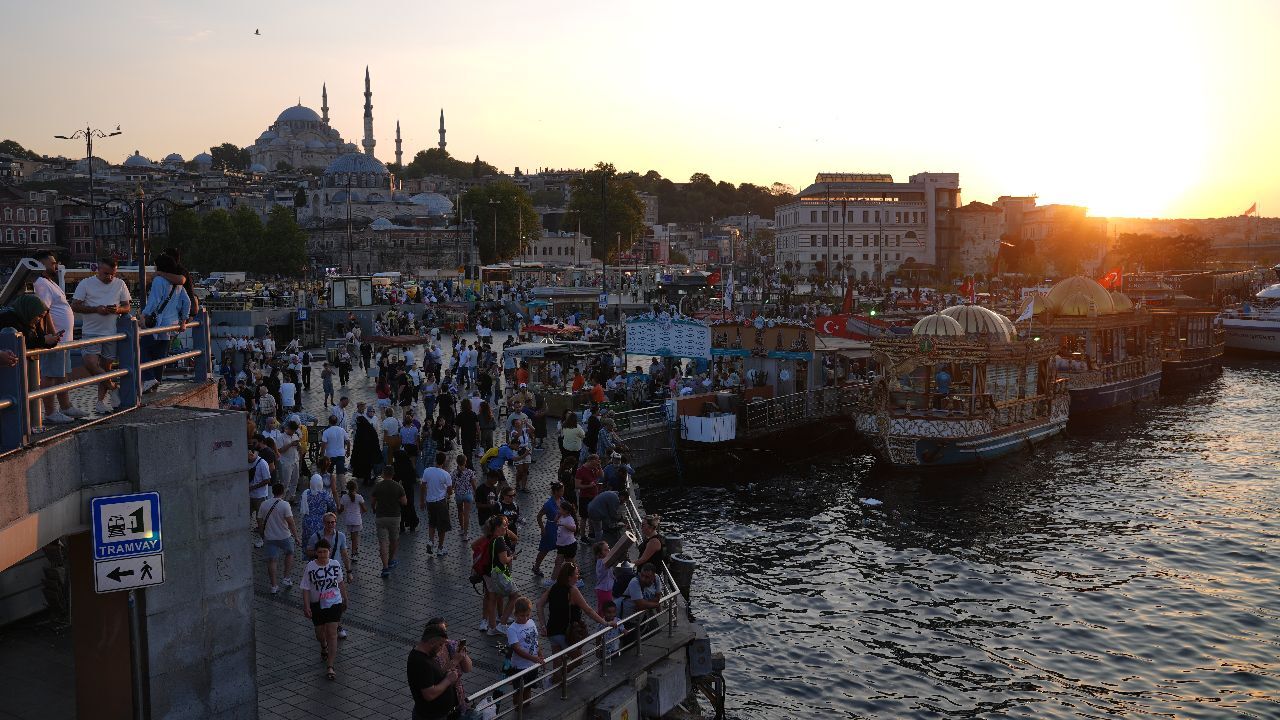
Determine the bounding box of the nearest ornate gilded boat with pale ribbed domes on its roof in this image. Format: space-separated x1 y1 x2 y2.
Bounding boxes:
854 305 1070 469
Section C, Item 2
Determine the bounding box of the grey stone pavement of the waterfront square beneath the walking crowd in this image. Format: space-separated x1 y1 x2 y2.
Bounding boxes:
254 333 614 720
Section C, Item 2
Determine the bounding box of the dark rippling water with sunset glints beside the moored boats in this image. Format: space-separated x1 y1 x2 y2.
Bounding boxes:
644 363 1280 719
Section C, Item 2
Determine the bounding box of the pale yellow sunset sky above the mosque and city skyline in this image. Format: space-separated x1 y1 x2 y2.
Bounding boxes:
0 0 1280 217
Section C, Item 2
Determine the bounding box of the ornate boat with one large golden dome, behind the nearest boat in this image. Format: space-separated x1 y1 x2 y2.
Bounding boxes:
1028 275 1164 416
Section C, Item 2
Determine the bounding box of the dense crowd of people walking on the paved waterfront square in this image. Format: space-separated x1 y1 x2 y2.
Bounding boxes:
230 322 664 719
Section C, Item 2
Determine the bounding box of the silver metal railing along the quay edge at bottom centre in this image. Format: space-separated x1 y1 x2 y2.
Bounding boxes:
467 484 681 719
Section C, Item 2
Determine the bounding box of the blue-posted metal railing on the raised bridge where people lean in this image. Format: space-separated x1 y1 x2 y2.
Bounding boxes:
0 310 212 452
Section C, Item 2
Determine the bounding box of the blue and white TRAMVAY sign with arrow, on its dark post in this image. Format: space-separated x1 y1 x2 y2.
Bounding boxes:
90 492 164 720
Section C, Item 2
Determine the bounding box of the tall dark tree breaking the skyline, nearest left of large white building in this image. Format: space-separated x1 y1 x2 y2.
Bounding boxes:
568 163 645 261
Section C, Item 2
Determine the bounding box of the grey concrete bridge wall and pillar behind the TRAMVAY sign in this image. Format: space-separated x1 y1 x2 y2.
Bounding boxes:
0 386 257 720
